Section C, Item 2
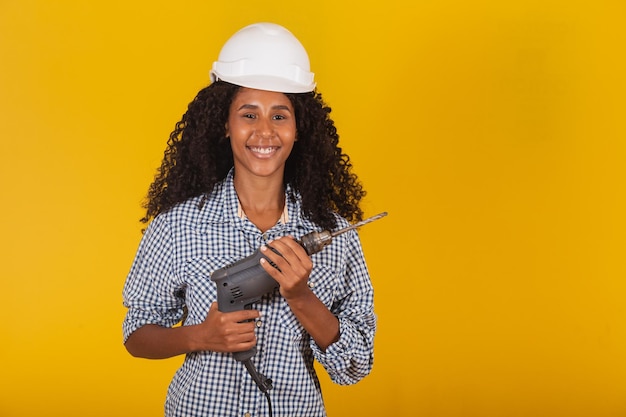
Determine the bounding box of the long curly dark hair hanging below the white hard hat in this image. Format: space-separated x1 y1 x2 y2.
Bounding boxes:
141 81 365 229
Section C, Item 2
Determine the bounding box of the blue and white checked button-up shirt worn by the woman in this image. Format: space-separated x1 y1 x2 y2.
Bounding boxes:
123 170 376 417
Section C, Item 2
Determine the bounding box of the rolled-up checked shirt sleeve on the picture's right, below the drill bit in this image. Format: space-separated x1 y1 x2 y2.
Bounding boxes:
311 233 376 385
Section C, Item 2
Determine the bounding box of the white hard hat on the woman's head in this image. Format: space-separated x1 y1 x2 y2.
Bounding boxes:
211 23 315 93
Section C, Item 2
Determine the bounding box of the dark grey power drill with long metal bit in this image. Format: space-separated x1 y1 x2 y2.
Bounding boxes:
211 212 387 393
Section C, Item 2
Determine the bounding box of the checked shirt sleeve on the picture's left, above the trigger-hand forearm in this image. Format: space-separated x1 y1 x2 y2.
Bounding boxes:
122 216 184 343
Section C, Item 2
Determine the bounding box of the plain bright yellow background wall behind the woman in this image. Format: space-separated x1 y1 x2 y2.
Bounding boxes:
0 0 626 417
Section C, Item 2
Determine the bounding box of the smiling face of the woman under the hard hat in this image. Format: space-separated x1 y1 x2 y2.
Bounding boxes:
226 88 296 181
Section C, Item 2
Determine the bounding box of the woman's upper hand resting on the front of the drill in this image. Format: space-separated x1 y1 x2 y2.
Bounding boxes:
261 236 313 301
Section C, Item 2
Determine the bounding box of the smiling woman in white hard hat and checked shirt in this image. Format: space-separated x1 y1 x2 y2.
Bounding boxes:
124 23 376 416
